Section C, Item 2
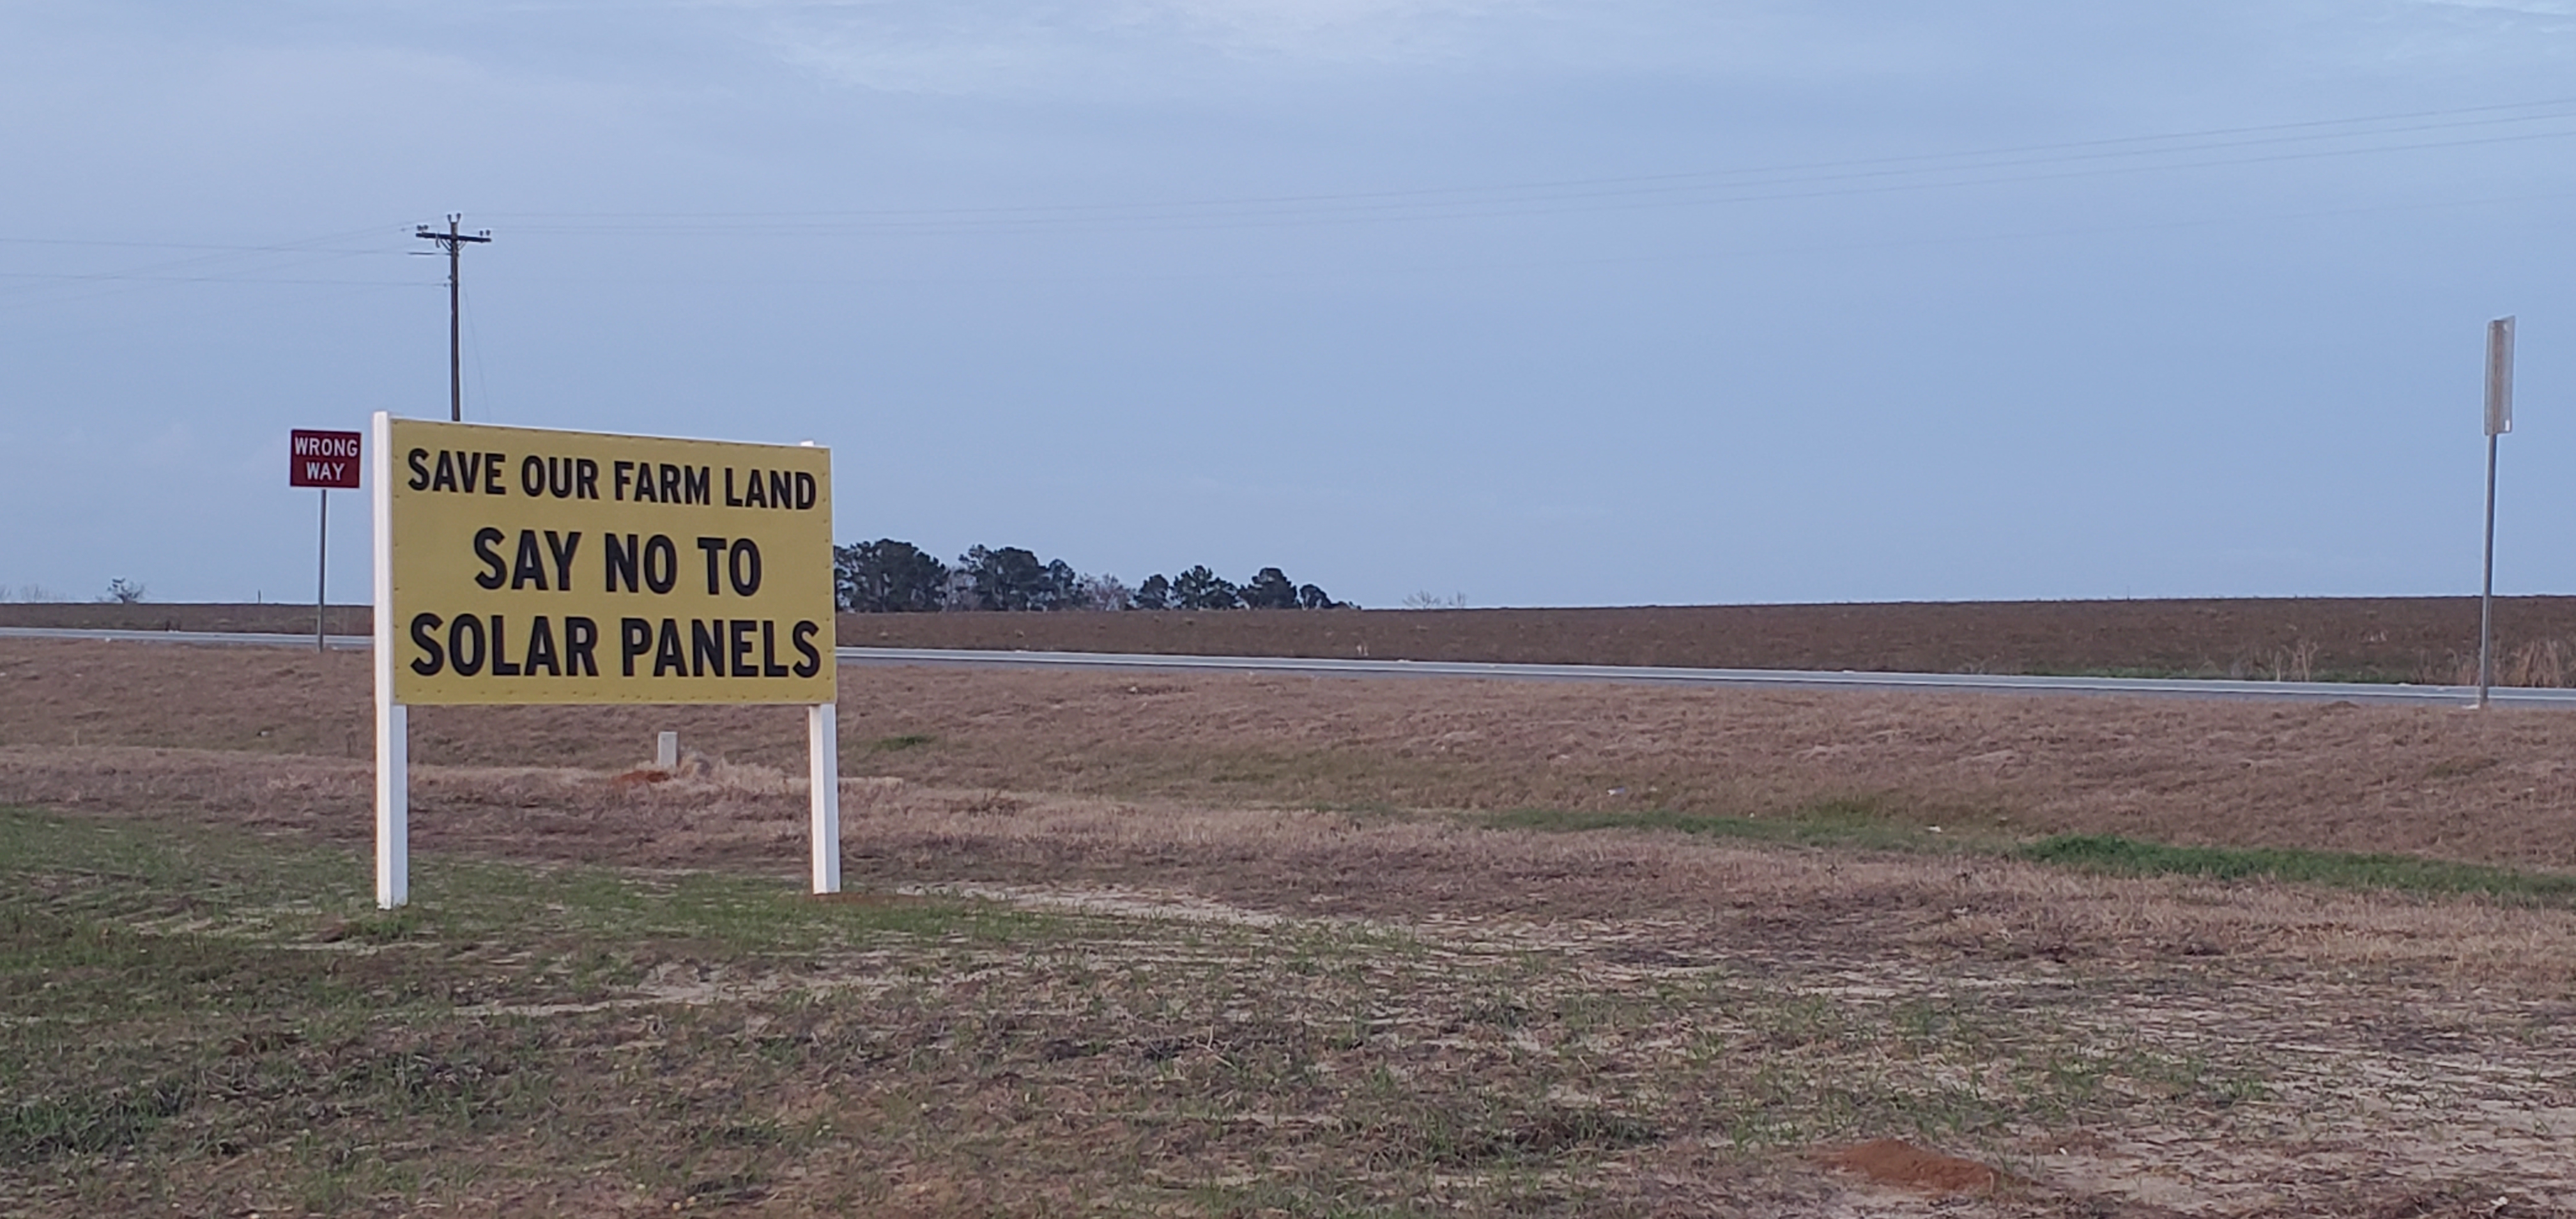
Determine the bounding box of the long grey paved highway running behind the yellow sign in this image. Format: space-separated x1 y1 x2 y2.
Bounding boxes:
0 626 2576 709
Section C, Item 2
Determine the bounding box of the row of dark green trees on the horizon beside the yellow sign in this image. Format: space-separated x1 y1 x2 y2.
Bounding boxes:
832 539 1350 613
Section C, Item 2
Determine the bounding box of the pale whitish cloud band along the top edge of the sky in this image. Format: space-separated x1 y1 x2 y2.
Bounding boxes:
732 0 2576 98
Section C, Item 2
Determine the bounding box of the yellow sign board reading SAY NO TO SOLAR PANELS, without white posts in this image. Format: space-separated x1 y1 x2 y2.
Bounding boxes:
376 420 834 703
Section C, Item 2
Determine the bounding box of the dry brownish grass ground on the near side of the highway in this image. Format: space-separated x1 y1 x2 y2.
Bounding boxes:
0 641 2576 1219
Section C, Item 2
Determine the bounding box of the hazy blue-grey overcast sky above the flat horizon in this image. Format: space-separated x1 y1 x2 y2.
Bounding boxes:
0 0 2576 606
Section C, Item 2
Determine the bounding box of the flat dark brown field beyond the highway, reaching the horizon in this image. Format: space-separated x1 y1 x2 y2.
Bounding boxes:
25 598 2576 686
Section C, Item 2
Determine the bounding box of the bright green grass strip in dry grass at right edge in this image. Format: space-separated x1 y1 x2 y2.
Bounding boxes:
2014 835 2576 905
